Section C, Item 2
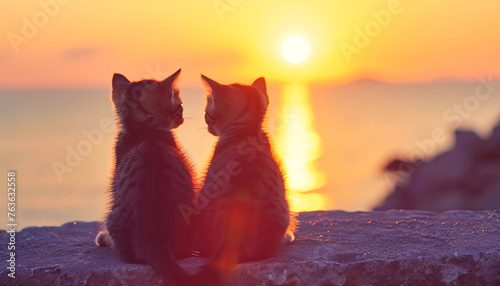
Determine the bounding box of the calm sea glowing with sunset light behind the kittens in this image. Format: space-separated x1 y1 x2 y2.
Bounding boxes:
0 81 500 228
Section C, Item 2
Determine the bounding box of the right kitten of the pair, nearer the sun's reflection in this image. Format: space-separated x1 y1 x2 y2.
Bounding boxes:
192 75 296 285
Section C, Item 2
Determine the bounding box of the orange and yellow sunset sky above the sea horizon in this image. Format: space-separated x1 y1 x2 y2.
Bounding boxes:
0 0 500 89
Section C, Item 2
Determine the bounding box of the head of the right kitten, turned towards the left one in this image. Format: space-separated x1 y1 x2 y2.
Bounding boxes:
201 75 269 136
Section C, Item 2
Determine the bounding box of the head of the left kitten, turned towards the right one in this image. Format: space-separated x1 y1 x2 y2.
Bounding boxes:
111 69 184 130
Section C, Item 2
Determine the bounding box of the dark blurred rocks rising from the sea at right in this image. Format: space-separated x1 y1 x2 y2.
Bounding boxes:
375 118 500 211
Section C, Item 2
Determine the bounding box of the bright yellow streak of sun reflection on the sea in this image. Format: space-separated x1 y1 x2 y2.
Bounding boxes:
277 84 326 212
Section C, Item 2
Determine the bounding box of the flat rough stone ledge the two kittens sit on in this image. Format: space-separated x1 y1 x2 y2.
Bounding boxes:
0 210 500 285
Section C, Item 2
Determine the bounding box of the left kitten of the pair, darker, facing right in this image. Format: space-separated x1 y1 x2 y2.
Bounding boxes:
96 69 194 280
